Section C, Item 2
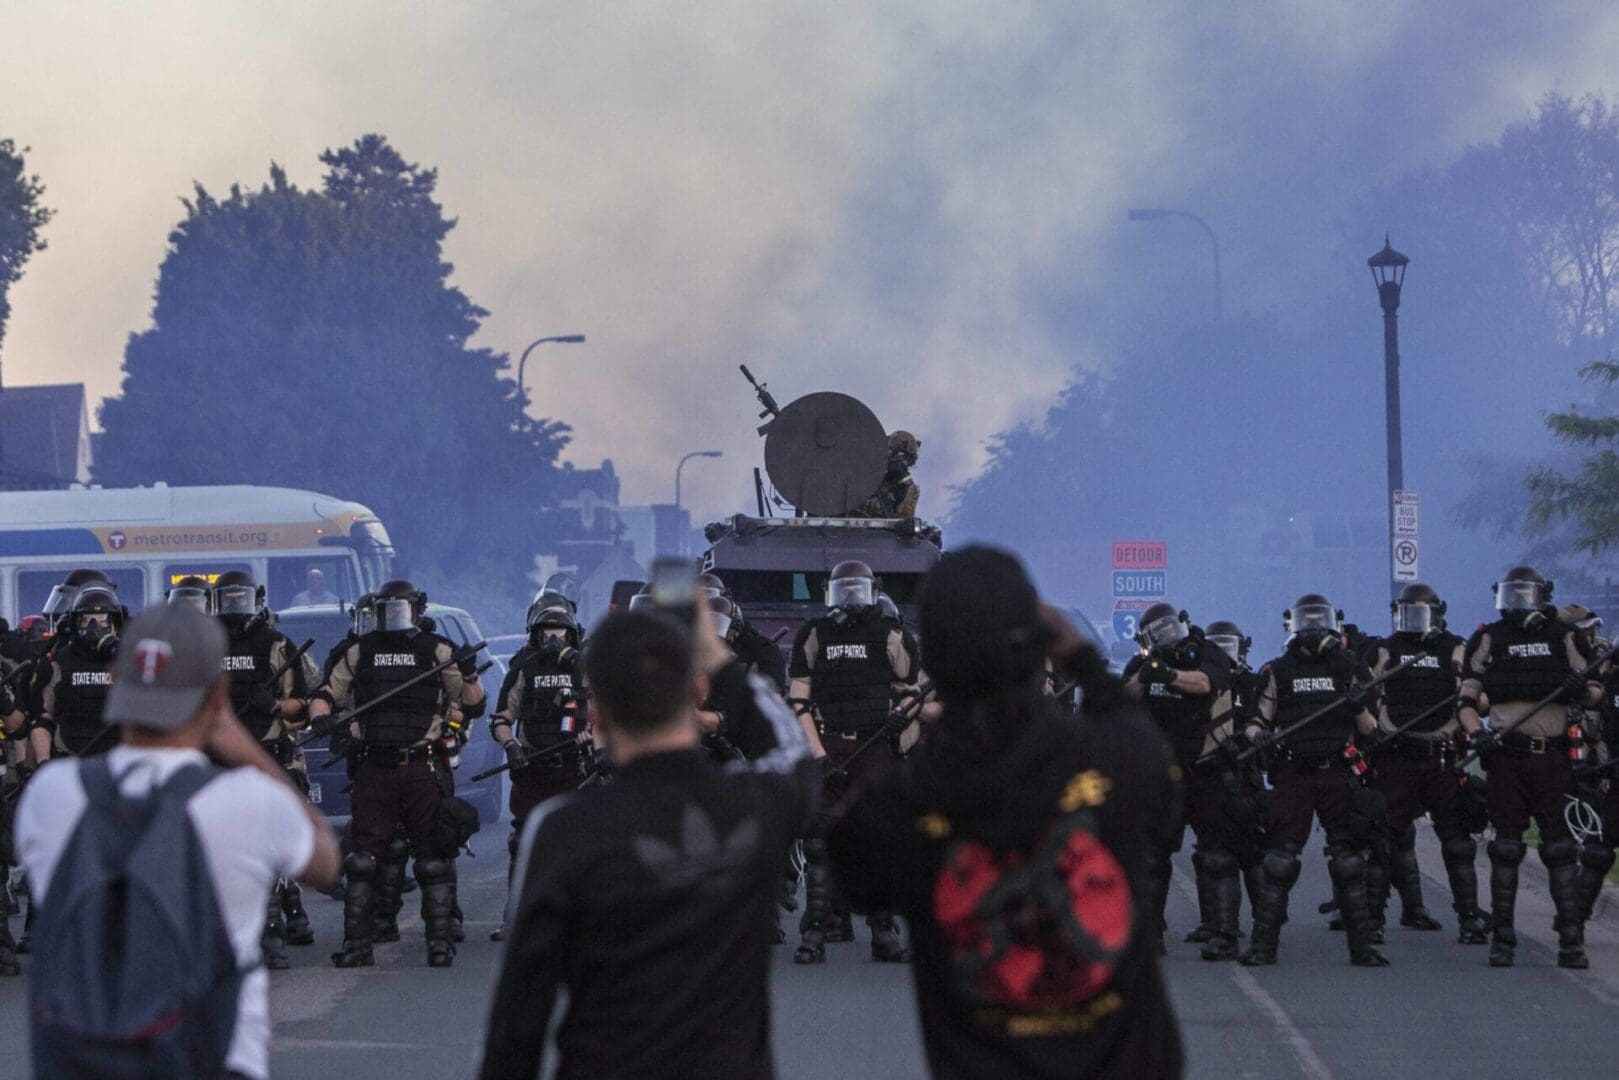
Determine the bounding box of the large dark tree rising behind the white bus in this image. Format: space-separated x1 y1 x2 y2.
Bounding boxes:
97 134 567 588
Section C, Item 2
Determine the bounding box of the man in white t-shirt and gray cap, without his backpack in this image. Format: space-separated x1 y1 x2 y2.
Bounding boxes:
15 606 340 1080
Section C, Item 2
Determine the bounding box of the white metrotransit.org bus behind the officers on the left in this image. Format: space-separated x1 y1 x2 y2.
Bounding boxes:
0 484 393 625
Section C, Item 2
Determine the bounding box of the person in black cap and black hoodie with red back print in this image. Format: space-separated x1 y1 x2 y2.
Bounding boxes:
827 547 1182 1080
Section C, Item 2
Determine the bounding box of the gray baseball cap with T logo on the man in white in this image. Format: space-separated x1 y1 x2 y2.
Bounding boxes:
102 604 225 730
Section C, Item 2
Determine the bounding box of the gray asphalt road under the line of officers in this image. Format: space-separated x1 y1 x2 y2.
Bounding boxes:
9 829 1619 1080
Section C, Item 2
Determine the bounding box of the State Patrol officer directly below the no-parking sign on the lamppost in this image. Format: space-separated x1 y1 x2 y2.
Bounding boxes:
1370 581 1488 946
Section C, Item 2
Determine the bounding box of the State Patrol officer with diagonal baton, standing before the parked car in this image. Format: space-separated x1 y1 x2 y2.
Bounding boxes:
309 581 482 967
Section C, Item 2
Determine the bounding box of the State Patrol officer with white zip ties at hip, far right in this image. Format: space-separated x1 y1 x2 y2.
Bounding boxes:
1459 567 1601 968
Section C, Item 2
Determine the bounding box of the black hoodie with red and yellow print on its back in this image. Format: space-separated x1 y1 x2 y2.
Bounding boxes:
829 699 1182 1080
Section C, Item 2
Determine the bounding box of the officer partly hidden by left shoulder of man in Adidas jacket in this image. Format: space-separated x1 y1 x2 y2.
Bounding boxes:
489 596 589 941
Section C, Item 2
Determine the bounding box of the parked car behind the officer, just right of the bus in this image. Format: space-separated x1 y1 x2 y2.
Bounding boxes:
275 604 505 824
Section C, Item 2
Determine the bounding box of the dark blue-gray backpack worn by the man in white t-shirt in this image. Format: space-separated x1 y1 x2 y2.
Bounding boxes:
29 758 256 1080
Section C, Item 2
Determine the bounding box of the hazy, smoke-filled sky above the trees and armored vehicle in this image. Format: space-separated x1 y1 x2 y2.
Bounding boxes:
0 0 1619 513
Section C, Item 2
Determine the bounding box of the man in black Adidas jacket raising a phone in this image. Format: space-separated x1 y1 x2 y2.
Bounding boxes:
479 607 818 1080
